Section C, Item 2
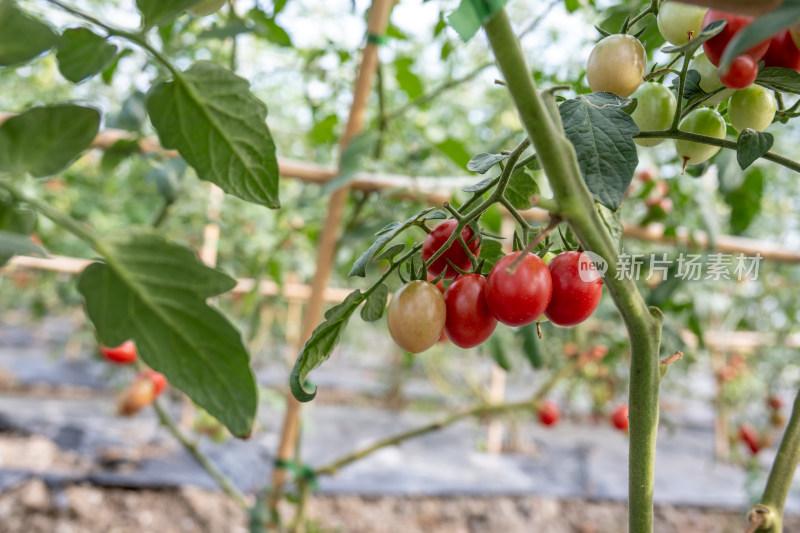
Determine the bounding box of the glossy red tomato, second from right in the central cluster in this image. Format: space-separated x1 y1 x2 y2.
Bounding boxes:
486 251 555 326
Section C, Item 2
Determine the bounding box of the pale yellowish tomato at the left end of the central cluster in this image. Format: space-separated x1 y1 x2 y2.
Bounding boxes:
386 280 447 353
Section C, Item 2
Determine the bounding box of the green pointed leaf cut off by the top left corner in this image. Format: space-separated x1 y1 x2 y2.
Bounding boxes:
0 0 58 67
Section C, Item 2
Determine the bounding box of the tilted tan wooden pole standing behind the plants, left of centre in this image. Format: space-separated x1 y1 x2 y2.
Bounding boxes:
268 0 394 509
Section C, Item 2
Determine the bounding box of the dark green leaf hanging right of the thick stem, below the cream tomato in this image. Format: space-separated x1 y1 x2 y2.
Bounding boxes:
559 92 639 211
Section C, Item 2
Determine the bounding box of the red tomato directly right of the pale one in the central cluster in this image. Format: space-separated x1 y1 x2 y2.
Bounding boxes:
444 274 497 348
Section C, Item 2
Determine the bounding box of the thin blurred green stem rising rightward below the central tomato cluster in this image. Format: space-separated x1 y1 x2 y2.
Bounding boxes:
314 363 576 476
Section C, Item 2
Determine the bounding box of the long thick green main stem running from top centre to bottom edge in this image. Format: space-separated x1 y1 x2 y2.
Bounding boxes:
485 10 662 533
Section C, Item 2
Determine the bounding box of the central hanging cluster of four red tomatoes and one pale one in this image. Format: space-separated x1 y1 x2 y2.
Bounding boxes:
387 220 603 353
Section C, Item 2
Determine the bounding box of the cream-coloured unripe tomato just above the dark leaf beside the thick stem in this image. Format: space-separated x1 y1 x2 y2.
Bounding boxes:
586 34 647 98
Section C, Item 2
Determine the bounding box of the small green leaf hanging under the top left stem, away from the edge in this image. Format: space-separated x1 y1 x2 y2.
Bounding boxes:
56 28 117 83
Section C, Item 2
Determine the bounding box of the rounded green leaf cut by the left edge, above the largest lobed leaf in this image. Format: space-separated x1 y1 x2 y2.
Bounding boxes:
0 104 100 177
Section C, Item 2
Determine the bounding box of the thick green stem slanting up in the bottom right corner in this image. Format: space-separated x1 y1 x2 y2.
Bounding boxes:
750 391 800 533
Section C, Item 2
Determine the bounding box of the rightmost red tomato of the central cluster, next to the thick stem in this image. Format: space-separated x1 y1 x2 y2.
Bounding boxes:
544 252 603 326
